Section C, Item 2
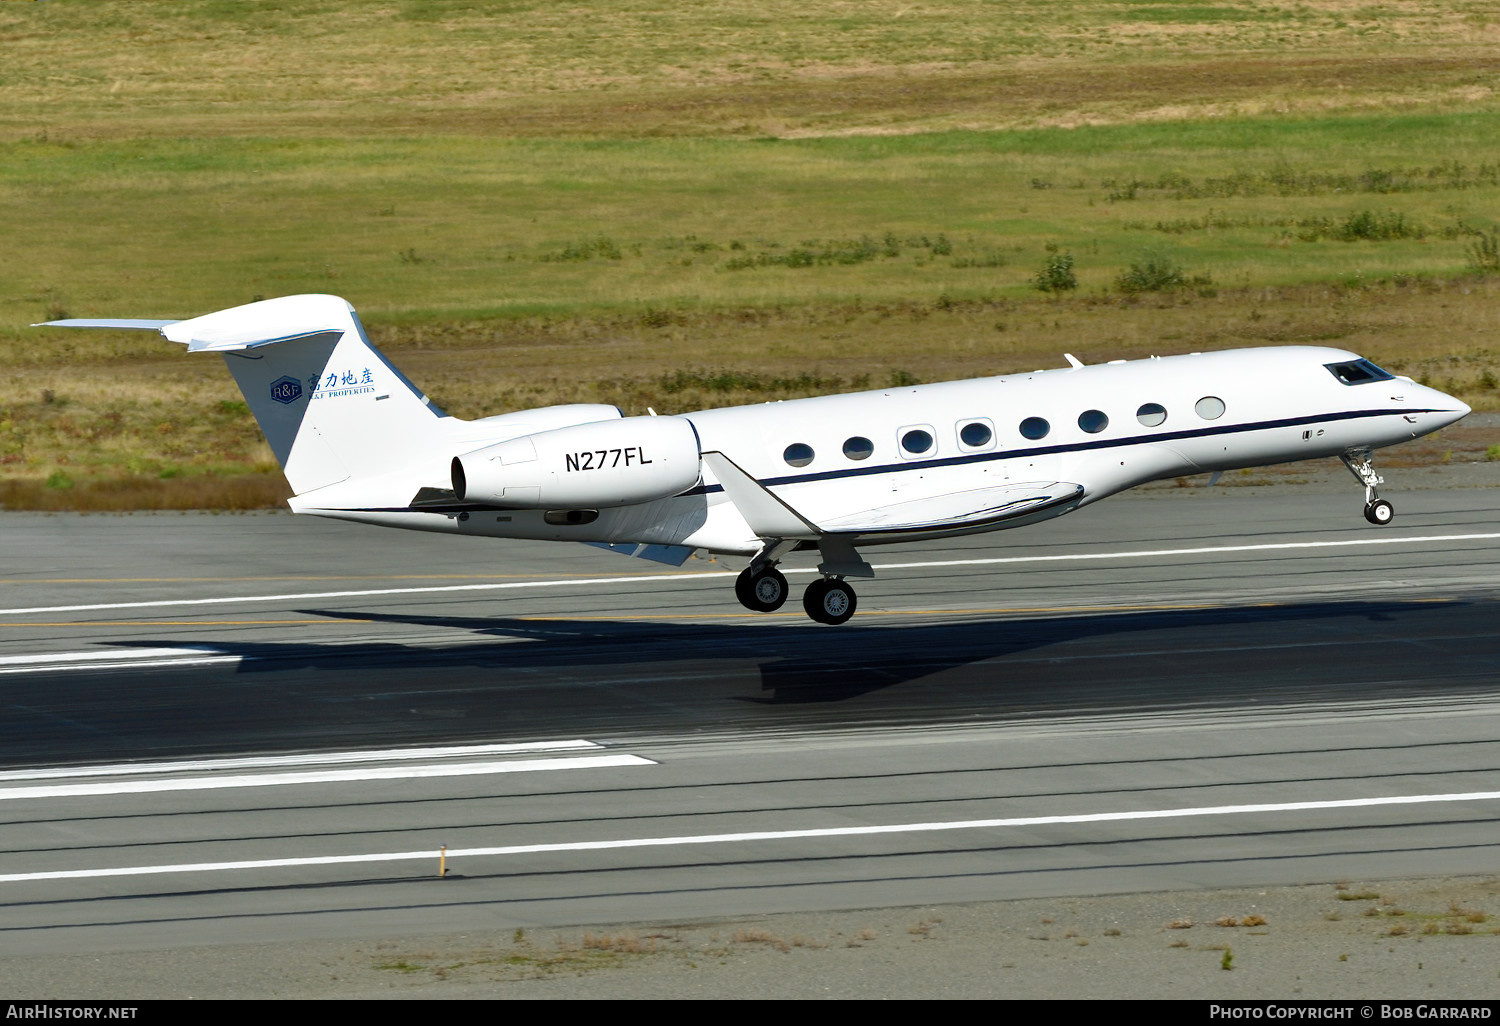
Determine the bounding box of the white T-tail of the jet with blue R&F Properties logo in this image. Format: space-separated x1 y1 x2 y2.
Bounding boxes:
38 296 449 497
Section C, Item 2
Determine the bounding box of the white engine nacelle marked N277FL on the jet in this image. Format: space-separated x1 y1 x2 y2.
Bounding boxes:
453 417 701 509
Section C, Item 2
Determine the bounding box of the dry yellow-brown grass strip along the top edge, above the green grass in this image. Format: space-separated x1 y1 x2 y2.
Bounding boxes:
0 0 1500 138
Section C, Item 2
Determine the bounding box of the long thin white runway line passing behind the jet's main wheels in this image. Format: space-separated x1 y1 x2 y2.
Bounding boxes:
0 533 1500 618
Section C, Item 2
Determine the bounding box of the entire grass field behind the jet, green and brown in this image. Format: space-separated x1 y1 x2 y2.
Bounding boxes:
0 0 1500 507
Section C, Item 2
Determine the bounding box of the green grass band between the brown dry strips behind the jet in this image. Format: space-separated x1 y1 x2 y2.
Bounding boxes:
0 114 1500 330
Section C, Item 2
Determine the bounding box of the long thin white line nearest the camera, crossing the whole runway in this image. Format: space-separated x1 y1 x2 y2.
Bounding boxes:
0 791 1500 884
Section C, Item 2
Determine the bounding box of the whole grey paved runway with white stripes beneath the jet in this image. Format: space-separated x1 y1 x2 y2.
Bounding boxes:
0 488 1500 953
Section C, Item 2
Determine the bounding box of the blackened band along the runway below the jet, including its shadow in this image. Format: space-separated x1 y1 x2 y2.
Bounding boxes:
0 599 1500 765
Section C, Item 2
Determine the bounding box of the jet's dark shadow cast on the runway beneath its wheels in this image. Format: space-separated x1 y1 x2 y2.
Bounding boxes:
108 602 1493 705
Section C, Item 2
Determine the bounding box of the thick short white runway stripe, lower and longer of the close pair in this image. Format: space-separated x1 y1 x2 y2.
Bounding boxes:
0 755 656 801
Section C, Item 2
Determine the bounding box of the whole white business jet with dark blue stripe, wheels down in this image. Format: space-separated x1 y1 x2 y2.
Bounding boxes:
48 296 1469 624
